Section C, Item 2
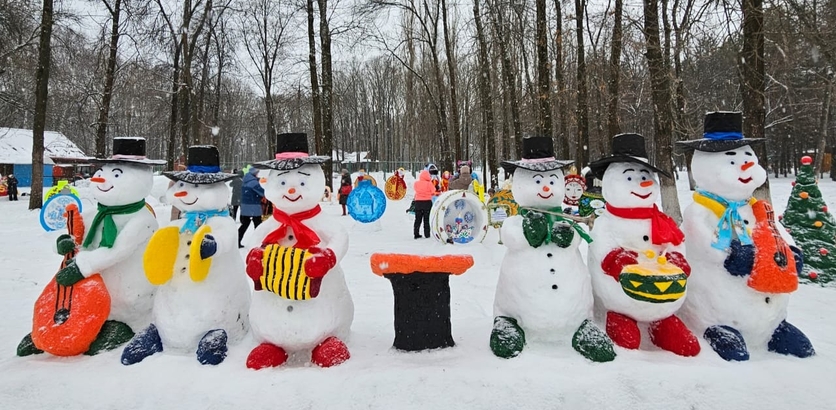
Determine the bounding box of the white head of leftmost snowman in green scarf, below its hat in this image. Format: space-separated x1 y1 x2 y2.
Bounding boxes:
90 162 154 206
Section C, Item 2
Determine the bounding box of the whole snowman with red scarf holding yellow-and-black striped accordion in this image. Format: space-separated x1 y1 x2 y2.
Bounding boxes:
246 134 354 369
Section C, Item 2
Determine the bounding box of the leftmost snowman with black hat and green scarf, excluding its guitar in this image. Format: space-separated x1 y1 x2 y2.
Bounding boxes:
56 138 165 354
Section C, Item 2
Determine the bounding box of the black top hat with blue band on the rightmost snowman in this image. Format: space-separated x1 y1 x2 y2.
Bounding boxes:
676 111 764 152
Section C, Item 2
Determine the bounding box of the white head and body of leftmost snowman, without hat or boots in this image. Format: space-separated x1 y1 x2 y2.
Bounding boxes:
75 163 159 330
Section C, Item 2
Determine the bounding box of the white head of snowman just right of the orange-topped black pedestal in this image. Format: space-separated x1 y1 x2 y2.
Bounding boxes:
511 168 566 209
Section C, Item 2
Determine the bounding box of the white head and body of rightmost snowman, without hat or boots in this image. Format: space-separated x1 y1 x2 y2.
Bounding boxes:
682 145 789 349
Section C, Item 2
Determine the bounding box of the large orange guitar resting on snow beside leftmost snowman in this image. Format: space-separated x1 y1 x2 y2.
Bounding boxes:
32 204 110 356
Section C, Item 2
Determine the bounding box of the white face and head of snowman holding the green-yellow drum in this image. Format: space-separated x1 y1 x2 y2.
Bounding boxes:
601 162 659 208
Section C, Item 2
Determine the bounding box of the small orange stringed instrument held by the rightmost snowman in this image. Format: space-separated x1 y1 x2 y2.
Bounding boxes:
748 200 798 293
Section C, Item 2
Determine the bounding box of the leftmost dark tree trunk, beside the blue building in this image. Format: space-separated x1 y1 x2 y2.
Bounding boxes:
29 0 53 209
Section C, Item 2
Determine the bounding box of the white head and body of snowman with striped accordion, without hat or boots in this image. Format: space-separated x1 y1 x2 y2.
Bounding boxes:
248 165 354 352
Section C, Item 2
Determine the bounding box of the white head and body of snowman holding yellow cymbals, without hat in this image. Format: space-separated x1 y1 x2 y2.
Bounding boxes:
153 181 250 352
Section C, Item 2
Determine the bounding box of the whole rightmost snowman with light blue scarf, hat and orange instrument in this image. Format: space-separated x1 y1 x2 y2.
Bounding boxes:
677 112 815 361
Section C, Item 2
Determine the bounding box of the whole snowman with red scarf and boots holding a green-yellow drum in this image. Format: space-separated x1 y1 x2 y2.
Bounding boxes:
588 134 700 356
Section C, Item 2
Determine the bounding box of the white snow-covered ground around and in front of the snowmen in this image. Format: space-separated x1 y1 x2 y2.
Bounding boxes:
0 175 836 410
